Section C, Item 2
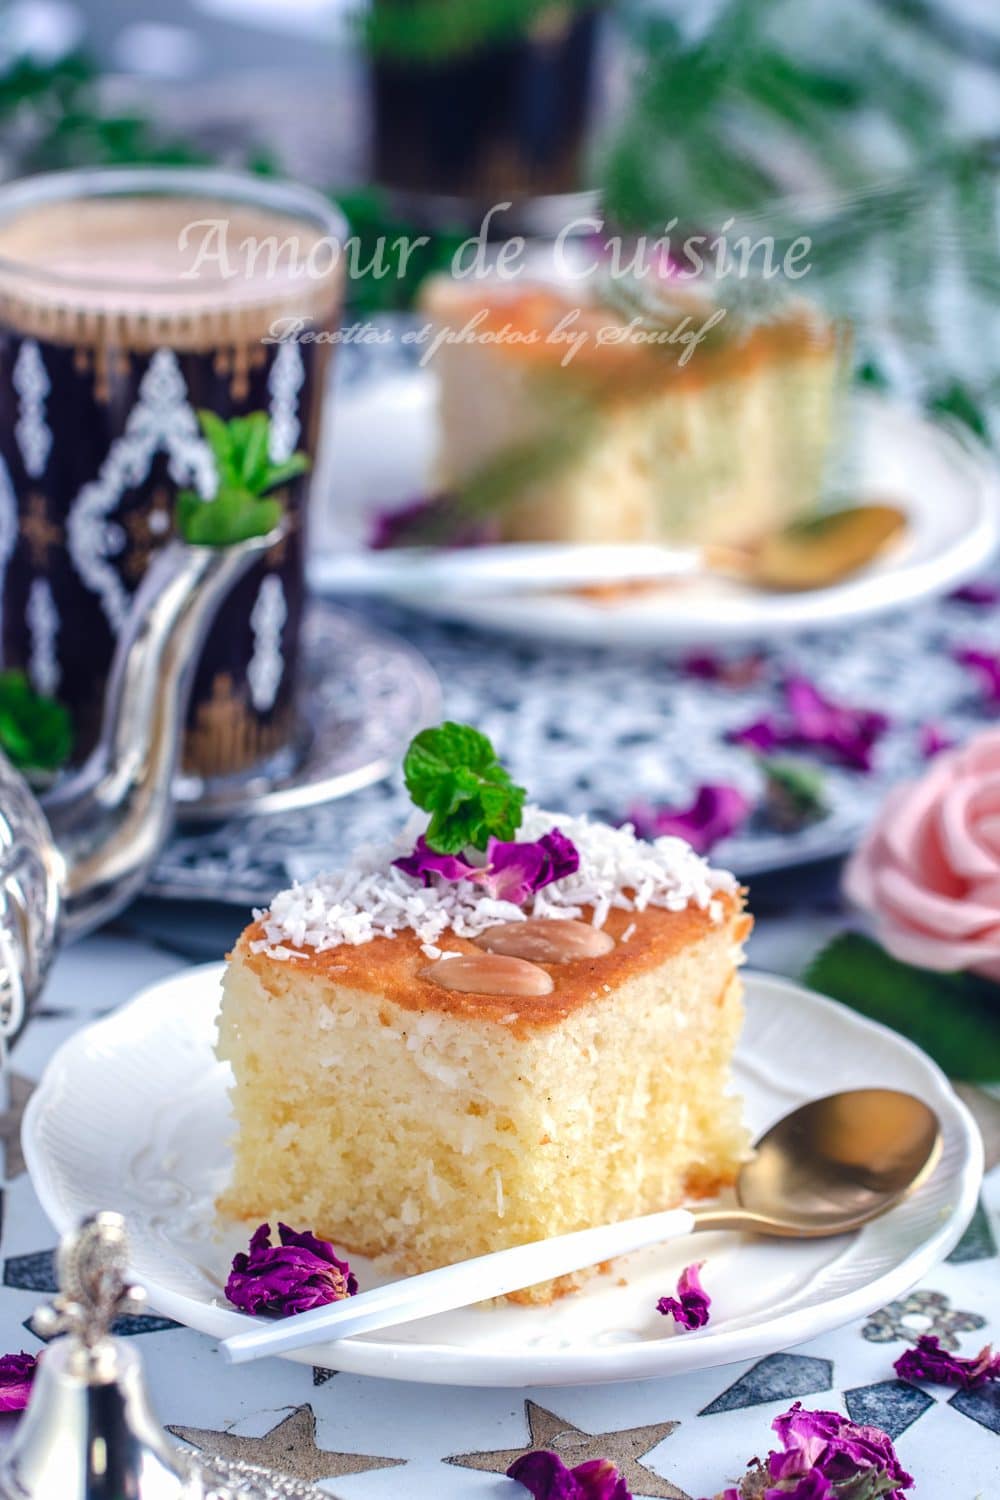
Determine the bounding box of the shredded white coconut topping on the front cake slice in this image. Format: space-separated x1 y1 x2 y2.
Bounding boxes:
252 807 736 959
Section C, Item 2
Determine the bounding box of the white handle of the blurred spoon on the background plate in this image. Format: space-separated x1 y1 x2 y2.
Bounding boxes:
309 542 705 594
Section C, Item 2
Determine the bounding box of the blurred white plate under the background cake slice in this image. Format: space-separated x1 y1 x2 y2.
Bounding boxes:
310 369 1000 647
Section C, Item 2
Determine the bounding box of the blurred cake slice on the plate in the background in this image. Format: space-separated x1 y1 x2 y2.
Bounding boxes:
423 278 844 546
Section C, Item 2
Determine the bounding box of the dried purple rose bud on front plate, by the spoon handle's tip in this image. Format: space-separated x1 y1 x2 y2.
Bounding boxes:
226 1224 358 1317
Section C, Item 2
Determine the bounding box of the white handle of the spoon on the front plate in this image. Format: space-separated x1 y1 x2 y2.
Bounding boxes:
222 1209 696 1365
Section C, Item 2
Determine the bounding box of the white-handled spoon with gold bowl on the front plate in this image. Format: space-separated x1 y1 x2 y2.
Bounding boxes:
222 1089 940 1365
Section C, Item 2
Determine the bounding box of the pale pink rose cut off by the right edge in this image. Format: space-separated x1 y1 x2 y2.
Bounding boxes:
844 729 1000 980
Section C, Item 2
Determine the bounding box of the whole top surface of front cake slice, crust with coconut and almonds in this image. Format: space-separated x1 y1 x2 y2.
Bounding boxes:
238 807 742 1022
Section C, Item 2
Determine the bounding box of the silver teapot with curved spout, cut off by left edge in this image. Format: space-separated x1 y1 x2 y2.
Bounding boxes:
0 527 282 1035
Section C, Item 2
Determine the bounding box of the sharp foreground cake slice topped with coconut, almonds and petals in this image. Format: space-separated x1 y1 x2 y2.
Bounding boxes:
219 726 750 1301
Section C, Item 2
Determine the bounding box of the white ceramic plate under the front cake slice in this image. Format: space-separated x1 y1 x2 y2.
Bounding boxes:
24 965 982 1386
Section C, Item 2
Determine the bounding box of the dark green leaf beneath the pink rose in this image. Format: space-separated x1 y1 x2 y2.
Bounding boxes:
804 933 1000 1083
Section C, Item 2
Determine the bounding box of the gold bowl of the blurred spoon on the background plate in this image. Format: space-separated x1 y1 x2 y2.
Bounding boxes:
705 503 907 593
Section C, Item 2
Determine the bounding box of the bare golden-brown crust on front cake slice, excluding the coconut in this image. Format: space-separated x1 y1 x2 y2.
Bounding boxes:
237 890 751 1035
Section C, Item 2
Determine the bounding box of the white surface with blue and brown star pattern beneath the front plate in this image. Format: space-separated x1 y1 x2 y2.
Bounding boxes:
0 903 1000 1500
